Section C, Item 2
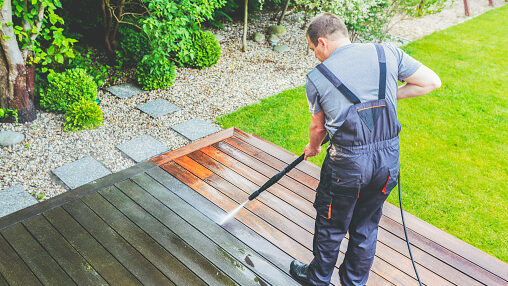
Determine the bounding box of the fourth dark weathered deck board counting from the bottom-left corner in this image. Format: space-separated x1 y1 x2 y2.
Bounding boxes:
44 207 141 285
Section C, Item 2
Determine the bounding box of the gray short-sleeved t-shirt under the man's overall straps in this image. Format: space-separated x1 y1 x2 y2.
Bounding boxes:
306 43 421 136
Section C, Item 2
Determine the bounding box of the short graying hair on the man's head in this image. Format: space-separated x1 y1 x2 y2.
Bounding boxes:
307 12 349 46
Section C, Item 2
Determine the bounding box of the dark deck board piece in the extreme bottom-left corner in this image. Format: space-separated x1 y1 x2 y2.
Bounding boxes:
0 235 42 286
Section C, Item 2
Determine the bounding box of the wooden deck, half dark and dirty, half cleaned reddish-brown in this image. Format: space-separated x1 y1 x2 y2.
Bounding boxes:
0 129 508 286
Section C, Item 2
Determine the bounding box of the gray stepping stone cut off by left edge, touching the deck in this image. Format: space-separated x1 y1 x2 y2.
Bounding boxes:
0 185 37 217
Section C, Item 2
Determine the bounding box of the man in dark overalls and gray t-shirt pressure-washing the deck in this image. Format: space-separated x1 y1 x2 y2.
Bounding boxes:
290 13 441 286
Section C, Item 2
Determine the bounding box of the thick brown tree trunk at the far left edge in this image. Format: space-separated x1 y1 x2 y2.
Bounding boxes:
0 0 37 122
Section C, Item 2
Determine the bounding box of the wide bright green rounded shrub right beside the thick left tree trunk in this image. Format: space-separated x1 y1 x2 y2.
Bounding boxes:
40 69 97 112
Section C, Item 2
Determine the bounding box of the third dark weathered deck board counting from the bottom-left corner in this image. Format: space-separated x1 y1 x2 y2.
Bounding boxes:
23 216 107 285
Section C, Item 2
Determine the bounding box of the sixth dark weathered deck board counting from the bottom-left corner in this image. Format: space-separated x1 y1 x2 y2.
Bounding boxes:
82 190 206 286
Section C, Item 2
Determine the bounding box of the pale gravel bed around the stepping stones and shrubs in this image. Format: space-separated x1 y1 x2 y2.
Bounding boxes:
0 0 504 198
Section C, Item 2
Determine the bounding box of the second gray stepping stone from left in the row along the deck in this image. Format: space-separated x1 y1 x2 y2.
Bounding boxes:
52 157 111 189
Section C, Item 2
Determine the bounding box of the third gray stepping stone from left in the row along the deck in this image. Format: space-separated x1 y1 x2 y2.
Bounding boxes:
116 135 169 163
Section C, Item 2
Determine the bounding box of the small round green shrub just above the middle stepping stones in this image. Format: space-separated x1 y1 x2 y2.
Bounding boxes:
136 57 176 90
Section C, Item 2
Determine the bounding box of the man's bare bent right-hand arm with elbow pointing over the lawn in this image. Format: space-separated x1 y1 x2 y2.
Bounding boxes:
397 65 441 99
